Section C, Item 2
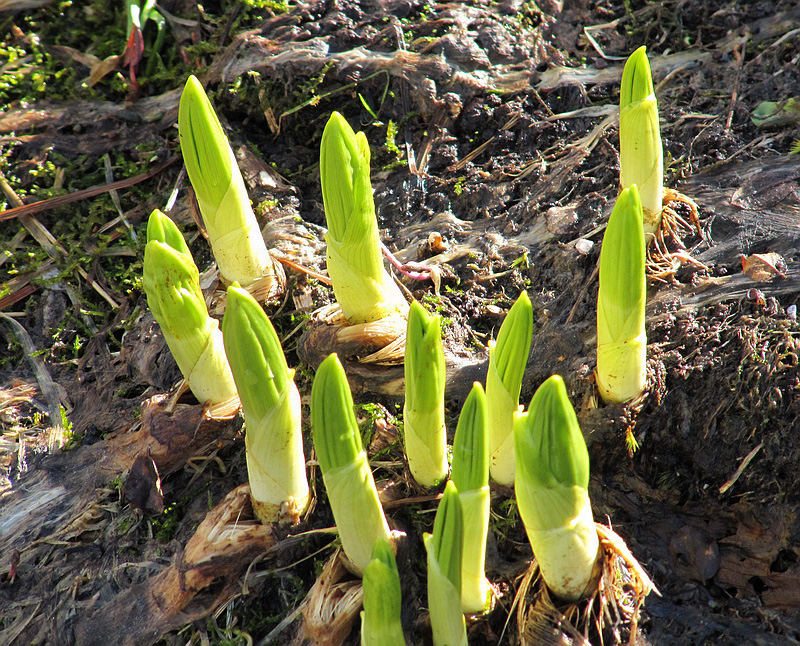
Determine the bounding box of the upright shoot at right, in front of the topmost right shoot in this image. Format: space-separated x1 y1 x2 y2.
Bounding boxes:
595 185 647 403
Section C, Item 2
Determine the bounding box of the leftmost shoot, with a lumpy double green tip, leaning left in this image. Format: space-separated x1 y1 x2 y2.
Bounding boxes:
142 209 236 404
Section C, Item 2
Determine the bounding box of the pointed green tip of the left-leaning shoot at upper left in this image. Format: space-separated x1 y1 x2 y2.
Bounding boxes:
178 75 233 209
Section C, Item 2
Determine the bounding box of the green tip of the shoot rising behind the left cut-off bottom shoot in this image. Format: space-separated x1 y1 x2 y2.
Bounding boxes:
311 353 363 472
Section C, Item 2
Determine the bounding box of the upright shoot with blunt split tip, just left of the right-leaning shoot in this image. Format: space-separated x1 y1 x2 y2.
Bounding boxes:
403 301 447 487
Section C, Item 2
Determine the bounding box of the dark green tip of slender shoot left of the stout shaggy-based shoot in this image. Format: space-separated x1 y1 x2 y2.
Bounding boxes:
451 382 489 493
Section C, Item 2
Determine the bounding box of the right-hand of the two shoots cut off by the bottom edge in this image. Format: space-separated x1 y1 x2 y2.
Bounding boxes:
422 481 467 646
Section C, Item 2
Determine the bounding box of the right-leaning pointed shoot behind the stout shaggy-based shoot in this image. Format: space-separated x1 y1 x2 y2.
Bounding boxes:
486 292 533 487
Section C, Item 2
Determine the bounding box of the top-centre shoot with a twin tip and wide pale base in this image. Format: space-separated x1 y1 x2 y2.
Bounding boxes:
320 112 408 324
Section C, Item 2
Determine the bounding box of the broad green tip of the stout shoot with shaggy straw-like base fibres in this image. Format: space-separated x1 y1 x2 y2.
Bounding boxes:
515 375 589 489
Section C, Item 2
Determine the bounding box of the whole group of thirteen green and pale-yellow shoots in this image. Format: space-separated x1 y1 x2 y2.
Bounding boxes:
144 48 663 646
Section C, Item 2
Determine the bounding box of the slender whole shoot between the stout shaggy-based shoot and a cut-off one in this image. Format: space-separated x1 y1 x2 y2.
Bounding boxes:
450 382 492 614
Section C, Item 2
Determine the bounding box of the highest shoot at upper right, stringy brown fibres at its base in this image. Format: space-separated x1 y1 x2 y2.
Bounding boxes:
619 46 664 234
